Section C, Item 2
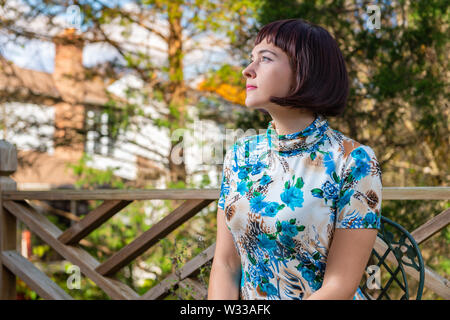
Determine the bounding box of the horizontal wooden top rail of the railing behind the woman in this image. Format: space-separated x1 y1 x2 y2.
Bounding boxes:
2 187 450 201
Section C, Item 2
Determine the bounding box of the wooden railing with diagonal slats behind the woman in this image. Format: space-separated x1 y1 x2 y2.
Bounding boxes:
0 140 450 299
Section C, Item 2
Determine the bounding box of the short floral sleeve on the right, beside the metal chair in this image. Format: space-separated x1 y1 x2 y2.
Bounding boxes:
336 145 382 229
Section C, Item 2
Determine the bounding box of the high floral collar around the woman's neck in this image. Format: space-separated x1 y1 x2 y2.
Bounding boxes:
266 114 328 156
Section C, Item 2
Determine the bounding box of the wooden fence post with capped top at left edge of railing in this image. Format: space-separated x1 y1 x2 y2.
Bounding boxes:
0 140 17 300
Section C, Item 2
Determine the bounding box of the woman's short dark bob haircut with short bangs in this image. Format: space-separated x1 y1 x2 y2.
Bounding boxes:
255 19 349 116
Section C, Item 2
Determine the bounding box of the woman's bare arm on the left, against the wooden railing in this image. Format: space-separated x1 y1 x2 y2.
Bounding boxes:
208 208 241 300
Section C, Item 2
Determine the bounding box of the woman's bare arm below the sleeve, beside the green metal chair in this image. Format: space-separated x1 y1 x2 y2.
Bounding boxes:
305 228 378 300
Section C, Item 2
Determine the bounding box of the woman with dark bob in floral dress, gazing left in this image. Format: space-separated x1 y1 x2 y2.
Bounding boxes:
208 19 382 299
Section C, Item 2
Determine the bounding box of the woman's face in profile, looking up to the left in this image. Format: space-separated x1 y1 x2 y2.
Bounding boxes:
242 39 293 110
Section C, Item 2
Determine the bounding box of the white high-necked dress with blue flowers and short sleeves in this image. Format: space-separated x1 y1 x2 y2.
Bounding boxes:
218 114 382 300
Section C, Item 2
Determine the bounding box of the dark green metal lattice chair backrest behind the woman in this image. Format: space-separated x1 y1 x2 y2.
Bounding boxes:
360 216 425 300
